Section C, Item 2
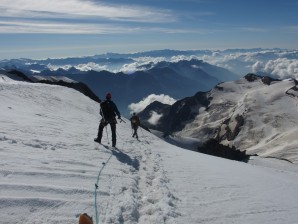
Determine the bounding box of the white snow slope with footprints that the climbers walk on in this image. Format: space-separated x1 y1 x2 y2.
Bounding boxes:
0 76 298 224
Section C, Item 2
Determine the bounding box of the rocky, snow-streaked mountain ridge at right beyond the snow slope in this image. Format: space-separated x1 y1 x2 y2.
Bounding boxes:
141 74 298 163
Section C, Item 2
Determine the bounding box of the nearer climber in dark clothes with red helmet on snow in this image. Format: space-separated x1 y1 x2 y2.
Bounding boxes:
94 93 121 147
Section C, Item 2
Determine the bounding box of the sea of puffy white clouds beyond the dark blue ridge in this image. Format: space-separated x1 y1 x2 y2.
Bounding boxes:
44 49 298 79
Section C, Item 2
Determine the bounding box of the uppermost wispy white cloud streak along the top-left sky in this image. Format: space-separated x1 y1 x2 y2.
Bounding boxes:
0 0 171 22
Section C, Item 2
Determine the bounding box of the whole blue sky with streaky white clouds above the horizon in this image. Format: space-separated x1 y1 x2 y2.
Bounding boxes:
0 0 298 59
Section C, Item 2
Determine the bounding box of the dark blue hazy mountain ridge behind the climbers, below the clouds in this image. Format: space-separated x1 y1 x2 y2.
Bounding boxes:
58 60 237 113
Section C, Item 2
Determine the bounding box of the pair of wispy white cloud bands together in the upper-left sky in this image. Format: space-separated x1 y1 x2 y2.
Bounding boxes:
0 0 175 34
